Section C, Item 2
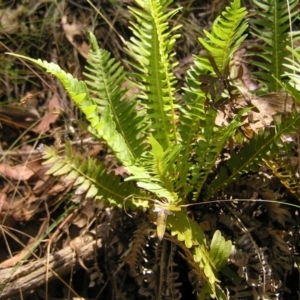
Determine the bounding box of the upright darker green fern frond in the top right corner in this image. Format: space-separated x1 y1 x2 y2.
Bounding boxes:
250 0 299 92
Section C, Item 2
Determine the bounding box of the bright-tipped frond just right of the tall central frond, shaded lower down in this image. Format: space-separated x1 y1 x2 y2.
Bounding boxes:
177 1 247 169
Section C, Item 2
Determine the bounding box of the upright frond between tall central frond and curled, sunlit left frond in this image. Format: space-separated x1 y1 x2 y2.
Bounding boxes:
84 33 146 159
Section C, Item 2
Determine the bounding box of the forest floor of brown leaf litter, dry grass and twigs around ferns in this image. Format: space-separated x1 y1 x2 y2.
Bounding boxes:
0 0 300 300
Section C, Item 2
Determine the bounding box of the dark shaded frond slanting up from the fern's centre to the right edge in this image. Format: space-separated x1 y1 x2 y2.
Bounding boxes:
205 115 300 199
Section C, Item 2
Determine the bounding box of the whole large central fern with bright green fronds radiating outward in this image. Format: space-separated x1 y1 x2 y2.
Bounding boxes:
7 0 299 299
